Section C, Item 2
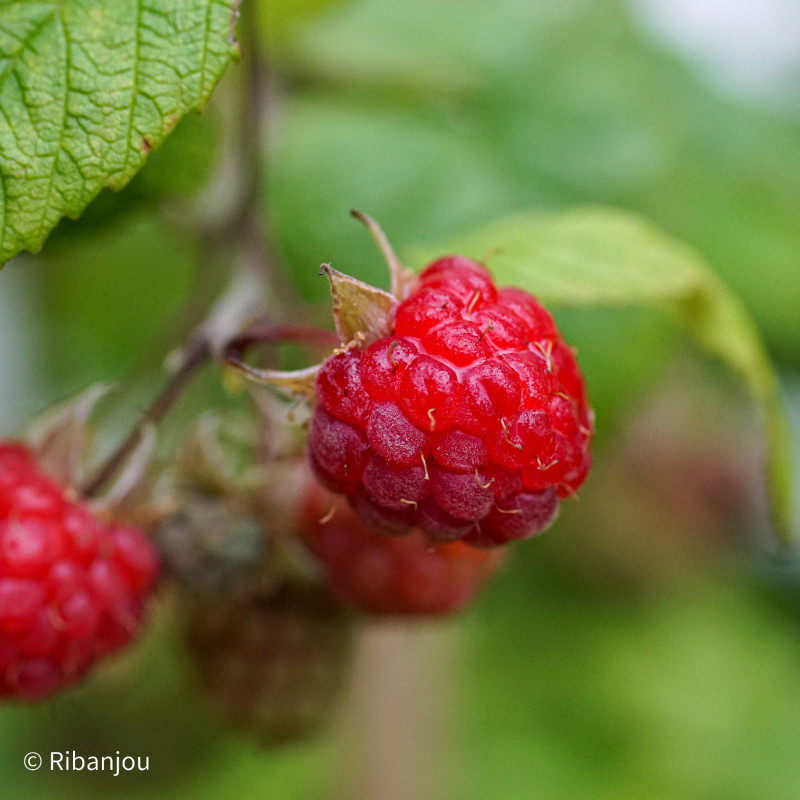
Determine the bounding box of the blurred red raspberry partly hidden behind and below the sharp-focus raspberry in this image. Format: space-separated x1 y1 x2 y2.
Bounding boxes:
299 490 503 616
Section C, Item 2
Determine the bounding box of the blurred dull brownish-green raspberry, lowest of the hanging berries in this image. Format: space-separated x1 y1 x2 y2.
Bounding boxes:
187 584 351 744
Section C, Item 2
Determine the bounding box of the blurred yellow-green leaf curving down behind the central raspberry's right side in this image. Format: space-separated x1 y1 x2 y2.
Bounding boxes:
414 208 793 543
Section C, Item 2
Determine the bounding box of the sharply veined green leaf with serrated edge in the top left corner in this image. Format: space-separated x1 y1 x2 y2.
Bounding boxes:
0 0 238 264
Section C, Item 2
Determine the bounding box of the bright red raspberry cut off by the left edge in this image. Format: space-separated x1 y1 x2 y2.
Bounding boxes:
0 442 158 700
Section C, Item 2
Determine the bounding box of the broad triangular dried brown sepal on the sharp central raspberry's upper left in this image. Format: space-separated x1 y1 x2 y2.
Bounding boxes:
319 264 397 347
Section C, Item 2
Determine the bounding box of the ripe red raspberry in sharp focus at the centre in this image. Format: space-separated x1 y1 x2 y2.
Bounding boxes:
309 256 593 547
